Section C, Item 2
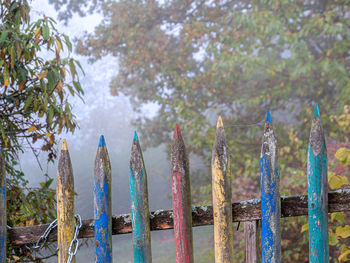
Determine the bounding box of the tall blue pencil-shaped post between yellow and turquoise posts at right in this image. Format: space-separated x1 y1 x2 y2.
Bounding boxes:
260 111 281 263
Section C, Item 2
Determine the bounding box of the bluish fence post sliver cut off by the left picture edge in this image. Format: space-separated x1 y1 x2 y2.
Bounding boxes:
0 149 7 263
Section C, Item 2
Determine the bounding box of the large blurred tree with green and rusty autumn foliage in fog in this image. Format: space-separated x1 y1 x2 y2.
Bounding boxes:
50 0 350 262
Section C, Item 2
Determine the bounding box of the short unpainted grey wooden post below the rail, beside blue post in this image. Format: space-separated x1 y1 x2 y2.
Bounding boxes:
244 220 261 263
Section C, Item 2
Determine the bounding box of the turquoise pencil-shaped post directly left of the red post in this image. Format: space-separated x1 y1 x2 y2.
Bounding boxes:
129 131 152 263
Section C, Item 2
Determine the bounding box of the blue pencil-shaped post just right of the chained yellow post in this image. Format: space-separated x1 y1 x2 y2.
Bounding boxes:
94 135 113 263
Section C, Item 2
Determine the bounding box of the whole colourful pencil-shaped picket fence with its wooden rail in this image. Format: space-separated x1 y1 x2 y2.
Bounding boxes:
0 105 350 263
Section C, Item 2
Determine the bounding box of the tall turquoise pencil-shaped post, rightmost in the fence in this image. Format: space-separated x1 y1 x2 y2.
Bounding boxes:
307 104 329 263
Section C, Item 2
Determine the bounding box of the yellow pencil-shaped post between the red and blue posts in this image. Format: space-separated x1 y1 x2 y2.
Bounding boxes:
211 117 233 263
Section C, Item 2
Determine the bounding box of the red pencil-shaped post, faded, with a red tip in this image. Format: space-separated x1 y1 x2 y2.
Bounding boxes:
171 124 194 263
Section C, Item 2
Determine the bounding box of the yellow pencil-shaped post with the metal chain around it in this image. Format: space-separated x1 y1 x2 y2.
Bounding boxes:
57 139 75 263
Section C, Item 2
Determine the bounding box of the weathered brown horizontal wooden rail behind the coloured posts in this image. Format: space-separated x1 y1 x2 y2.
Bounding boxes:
8 189 350 245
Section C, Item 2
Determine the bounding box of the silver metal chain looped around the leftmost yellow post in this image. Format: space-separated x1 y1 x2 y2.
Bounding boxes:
26 214 82 263
